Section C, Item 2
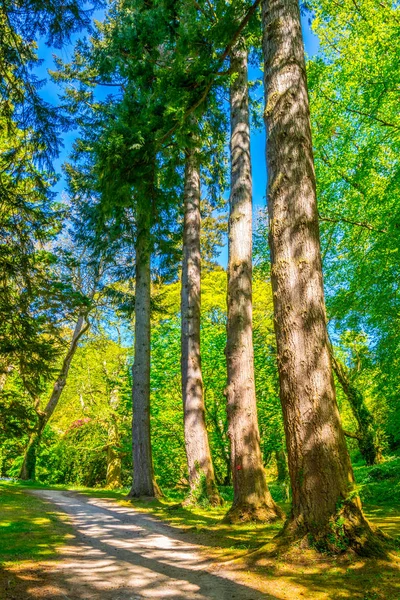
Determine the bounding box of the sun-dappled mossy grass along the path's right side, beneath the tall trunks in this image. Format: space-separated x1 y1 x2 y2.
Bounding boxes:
67 490 400 600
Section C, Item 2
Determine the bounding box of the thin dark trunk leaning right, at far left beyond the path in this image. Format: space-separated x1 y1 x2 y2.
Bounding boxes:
19 315 89 480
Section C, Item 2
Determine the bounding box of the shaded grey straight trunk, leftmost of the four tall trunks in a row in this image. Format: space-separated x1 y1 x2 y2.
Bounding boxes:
129 203 158 498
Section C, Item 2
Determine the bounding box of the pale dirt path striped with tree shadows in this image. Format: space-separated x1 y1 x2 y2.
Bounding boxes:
32 490 277 600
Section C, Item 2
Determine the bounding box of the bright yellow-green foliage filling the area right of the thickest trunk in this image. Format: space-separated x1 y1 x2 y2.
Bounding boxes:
308 0 400 449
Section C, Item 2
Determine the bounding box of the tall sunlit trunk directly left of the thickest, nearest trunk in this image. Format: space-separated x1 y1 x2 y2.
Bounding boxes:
226 41 281 522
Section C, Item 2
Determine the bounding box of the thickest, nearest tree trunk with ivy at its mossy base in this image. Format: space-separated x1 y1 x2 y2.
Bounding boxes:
262 0 373 552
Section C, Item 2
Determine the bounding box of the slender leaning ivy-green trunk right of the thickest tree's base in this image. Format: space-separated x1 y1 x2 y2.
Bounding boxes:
331 353 382 465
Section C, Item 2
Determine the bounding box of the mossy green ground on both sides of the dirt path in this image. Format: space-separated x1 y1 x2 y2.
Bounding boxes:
0 465 400 600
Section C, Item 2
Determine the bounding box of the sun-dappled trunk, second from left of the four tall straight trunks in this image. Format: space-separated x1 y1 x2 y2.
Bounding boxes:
181 149 221 505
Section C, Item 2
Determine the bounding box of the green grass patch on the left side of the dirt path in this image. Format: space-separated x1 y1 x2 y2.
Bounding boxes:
0 482 72 566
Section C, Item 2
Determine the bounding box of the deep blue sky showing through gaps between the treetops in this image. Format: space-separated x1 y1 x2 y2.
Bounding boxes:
36 11 318 266
